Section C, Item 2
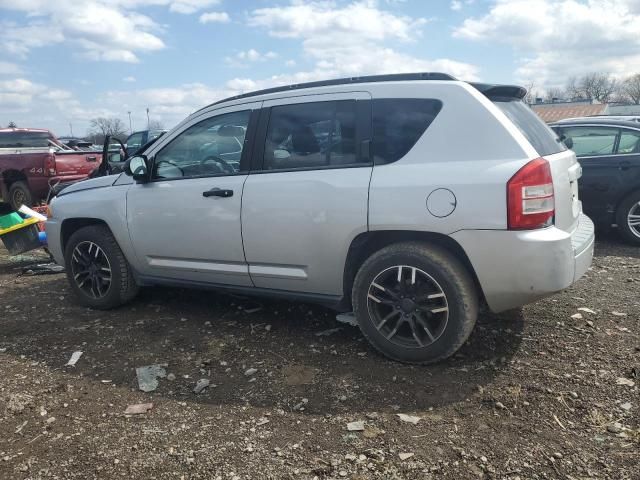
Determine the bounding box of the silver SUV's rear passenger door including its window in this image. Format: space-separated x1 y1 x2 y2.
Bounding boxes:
242 92 372 296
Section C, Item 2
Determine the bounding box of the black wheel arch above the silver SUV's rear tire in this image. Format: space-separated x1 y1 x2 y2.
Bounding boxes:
343 230 486 305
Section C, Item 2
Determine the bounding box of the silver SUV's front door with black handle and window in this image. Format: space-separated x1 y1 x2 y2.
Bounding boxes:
127 103 260 286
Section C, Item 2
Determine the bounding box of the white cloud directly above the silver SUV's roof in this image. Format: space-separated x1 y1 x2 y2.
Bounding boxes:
241 0 478 86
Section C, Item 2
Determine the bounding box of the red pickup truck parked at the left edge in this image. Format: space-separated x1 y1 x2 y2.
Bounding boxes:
0 128 102 209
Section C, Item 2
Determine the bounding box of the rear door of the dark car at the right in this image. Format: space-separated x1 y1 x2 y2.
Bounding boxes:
562 125 623 218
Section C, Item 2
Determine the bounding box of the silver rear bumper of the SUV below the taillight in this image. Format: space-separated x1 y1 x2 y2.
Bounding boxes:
451 214 595 312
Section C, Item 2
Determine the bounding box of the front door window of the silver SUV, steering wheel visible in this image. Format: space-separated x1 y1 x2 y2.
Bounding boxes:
153 110 251 179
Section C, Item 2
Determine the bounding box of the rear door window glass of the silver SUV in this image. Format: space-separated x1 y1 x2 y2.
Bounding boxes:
264 100 358 170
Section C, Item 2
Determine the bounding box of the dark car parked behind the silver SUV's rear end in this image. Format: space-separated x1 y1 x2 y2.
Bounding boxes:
551 117 640 245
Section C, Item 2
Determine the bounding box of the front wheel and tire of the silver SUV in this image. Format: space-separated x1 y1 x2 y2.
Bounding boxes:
64 225 139 310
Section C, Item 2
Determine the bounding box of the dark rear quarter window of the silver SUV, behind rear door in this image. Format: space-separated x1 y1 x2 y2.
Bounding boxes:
371 98 442 164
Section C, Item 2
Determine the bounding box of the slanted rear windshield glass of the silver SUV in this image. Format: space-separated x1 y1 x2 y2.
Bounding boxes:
493 100 567 157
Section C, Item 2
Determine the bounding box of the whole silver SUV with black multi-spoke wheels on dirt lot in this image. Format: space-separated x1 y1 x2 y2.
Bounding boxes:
47 73 594 363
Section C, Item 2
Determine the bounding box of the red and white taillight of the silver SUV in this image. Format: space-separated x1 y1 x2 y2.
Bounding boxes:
507 158 555 230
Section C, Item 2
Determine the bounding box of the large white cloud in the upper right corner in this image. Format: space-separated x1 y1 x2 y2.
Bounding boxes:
454 0 640 87
